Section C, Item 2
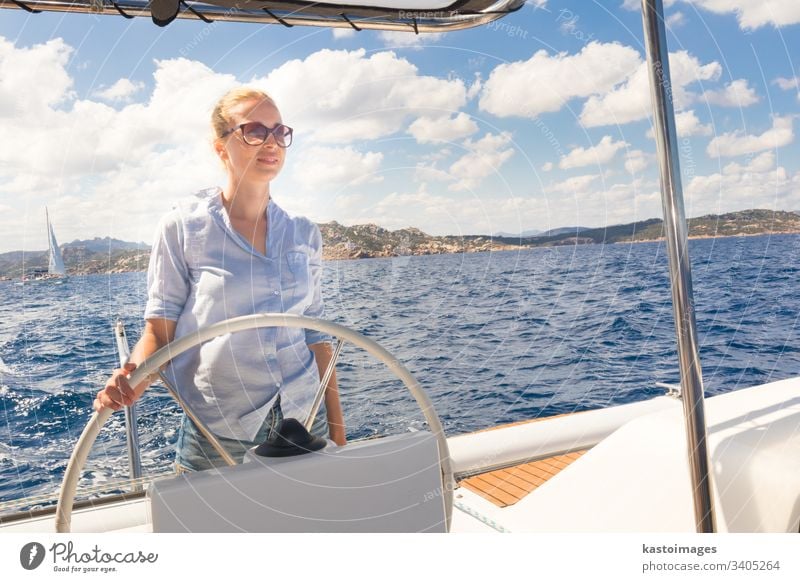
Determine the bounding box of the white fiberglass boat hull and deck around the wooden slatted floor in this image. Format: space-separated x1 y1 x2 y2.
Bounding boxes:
0 378 800 533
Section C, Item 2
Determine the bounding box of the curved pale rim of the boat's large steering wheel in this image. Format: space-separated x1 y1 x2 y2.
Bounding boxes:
56 313 454 533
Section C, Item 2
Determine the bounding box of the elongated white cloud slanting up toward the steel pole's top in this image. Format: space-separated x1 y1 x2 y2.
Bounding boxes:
479 42 640 118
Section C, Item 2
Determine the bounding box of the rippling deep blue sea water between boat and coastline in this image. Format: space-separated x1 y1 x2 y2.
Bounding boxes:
0 235 800 508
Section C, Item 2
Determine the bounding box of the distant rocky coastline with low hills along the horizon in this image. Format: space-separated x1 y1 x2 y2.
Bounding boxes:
0 209 800 280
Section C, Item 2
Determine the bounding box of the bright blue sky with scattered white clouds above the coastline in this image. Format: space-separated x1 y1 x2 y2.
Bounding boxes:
0 0 800 252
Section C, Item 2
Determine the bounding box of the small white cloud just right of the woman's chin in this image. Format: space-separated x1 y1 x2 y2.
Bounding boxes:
292 146 383 193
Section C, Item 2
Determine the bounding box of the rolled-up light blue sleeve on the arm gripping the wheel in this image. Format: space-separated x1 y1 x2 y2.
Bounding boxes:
144 211 190 321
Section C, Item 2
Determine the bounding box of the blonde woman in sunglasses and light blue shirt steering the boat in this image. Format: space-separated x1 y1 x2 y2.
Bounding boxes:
94 89 345 471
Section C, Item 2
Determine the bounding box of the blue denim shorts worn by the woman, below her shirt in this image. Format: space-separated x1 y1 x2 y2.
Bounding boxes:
175 397 328 473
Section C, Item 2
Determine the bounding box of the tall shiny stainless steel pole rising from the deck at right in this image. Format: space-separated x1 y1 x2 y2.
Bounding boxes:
642 0 716 533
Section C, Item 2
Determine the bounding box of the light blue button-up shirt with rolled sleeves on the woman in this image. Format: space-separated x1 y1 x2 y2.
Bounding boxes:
144 188 328 441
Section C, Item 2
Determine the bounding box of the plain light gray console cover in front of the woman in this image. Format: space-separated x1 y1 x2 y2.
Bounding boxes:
148 432 445 532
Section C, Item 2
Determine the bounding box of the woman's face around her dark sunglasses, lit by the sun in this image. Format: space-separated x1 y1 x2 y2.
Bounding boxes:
215 100 286 183
